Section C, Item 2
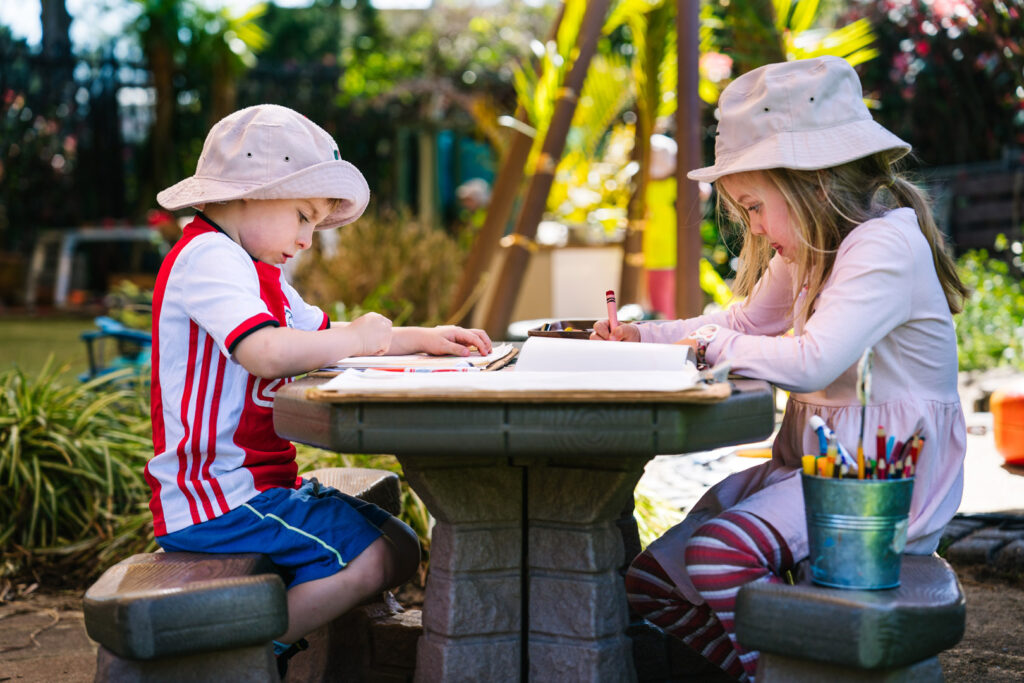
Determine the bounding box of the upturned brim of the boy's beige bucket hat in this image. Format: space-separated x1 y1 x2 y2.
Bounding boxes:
157 160 370 230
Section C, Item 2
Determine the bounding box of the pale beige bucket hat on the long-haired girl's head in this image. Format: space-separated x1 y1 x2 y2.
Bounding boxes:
686 56 910 182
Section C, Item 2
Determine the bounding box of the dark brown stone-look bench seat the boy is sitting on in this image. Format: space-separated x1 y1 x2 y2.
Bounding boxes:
83 468 400 683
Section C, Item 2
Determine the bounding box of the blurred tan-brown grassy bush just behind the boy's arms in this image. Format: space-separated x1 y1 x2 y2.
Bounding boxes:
294 212 464 325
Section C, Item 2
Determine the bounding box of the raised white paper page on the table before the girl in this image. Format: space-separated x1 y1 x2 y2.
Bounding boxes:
515 337 694 373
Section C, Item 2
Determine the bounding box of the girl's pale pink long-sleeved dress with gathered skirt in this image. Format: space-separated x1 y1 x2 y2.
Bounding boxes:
640 208 967 604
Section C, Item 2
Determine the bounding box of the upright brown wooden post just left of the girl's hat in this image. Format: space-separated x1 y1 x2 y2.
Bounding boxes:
676 0 703 317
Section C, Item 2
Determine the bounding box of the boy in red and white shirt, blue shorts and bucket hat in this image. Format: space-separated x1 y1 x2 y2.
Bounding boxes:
145 104 490 668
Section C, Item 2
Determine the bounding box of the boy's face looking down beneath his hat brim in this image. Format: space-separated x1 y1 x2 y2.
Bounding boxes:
231 199 331 265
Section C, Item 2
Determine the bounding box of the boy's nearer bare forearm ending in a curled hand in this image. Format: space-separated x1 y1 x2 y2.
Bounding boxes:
232 313 391 379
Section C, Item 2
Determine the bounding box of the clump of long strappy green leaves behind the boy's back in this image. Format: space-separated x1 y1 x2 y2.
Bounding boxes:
0 361 153 578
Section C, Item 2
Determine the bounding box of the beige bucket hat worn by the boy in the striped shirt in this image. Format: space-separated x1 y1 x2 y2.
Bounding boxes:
157 104 370 230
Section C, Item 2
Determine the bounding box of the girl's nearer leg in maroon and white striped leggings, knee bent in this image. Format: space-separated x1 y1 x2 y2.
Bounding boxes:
686 510 794 680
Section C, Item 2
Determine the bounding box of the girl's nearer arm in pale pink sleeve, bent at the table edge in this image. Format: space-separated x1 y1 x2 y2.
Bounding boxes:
707 221 913 392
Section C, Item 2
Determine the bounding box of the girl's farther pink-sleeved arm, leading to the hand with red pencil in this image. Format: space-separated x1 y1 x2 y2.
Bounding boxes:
637 256 794 343
